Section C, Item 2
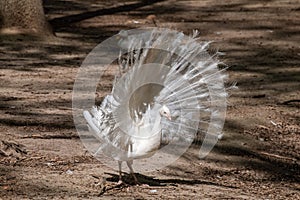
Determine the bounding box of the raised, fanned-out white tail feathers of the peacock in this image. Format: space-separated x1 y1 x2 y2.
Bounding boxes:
116 29 227 157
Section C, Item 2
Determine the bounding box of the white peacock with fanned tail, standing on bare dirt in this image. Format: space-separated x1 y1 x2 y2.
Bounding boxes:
83 29 227 182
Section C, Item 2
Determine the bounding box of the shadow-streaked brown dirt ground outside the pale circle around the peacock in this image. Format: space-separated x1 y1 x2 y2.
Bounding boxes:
0 0 300 199
